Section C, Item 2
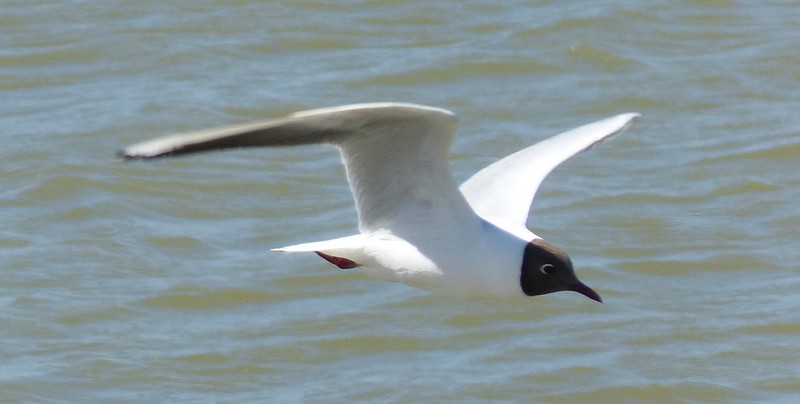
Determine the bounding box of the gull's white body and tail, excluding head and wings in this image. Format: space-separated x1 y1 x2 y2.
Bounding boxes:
275 219 527 298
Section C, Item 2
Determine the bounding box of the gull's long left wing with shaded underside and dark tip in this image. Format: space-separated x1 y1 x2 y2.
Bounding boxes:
119 103 476 233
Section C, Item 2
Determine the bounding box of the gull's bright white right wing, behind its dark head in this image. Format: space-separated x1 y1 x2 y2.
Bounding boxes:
461 113 639 234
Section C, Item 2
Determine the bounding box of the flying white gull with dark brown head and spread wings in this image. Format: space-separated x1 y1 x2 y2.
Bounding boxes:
118 102 639 302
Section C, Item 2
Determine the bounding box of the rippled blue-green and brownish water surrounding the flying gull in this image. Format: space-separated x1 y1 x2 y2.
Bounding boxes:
0 0 800 402
